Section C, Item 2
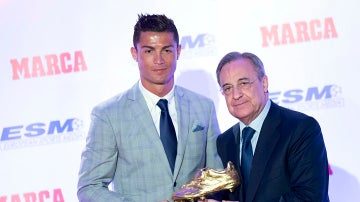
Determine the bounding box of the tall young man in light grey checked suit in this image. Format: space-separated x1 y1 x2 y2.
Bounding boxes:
78 15 223 202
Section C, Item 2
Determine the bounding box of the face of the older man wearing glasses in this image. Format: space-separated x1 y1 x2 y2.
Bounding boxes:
220 59 268 124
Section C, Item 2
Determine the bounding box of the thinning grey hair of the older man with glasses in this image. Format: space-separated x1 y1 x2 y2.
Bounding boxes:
216 51 265 85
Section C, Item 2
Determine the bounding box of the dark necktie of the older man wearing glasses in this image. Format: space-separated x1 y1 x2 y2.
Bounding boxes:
241 127 255 196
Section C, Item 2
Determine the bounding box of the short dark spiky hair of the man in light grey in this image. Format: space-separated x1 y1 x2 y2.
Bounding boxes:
133 14 179 48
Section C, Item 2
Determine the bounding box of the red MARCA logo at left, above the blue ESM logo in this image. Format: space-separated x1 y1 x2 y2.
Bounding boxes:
10 51 87 80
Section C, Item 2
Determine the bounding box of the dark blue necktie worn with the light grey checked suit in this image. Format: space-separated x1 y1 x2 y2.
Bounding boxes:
157 99 177 173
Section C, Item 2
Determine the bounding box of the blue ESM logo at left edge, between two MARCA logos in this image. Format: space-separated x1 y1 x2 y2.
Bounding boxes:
0 118 84 150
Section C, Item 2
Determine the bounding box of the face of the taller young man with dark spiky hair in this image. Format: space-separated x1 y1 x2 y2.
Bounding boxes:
131 32 181 91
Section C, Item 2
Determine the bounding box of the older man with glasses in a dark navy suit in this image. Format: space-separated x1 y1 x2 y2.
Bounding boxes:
216 52 329 202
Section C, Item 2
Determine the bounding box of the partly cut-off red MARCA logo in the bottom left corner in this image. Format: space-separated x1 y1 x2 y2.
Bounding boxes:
0 189 64 202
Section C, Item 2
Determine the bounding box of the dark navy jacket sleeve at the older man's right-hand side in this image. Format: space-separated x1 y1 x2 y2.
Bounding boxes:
280 117 329 202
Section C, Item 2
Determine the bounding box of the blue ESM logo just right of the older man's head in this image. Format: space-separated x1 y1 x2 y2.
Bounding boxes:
269 85 344 111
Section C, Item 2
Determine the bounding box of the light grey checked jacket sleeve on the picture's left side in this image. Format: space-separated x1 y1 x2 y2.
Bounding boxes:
78 108 124 202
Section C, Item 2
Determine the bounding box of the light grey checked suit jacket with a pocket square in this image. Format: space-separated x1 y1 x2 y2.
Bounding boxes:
78 84 223 202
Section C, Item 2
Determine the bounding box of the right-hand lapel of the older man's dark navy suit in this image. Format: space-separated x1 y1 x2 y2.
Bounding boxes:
246 102 281 201
